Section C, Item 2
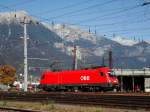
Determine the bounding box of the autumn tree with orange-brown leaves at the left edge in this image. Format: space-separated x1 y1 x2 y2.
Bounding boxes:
0 65 16 85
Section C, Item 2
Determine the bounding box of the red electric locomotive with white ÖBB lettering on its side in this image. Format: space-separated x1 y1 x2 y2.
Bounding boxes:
40 67 118 91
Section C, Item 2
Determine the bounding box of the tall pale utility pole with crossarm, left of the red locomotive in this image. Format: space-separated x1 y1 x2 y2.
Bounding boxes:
21 17 29 92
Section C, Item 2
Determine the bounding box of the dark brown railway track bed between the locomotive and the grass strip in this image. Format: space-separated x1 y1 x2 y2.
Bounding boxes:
0 92 150 110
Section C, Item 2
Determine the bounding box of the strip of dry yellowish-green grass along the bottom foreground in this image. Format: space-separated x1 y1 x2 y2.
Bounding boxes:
0 101 145 112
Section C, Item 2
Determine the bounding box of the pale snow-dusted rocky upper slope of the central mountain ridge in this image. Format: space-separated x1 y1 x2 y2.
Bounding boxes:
43 24 96 44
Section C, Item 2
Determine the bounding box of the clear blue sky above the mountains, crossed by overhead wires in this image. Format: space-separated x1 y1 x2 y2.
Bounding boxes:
0 0 150 40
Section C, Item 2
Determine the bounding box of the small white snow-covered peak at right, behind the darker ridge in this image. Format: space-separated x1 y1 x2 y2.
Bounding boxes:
112 36 138 46
